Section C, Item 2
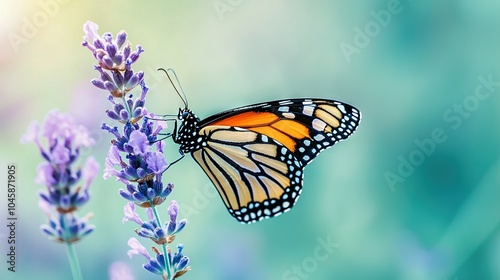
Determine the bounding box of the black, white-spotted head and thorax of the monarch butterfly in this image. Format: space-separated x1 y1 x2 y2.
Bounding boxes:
176 108 201 153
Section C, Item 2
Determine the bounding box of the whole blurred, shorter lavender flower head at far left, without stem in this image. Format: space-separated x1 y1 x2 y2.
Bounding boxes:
21 110 99 238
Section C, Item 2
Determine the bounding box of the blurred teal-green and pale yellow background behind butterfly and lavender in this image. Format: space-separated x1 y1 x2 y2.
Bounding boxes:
0 0 500 280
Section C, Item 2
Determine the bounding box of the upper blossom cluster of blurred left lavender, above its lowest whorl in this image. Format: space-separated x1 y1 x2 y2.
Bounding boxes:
21 110 99 220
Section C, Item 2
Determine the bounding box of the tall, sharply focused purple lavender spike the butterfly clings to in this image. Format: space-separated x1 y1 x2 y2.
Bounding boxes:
83 21 190 280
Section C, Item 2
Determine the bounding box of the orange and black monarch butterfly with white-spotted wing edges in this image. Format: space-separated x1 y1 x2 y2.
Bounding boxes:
163 73 361 223
